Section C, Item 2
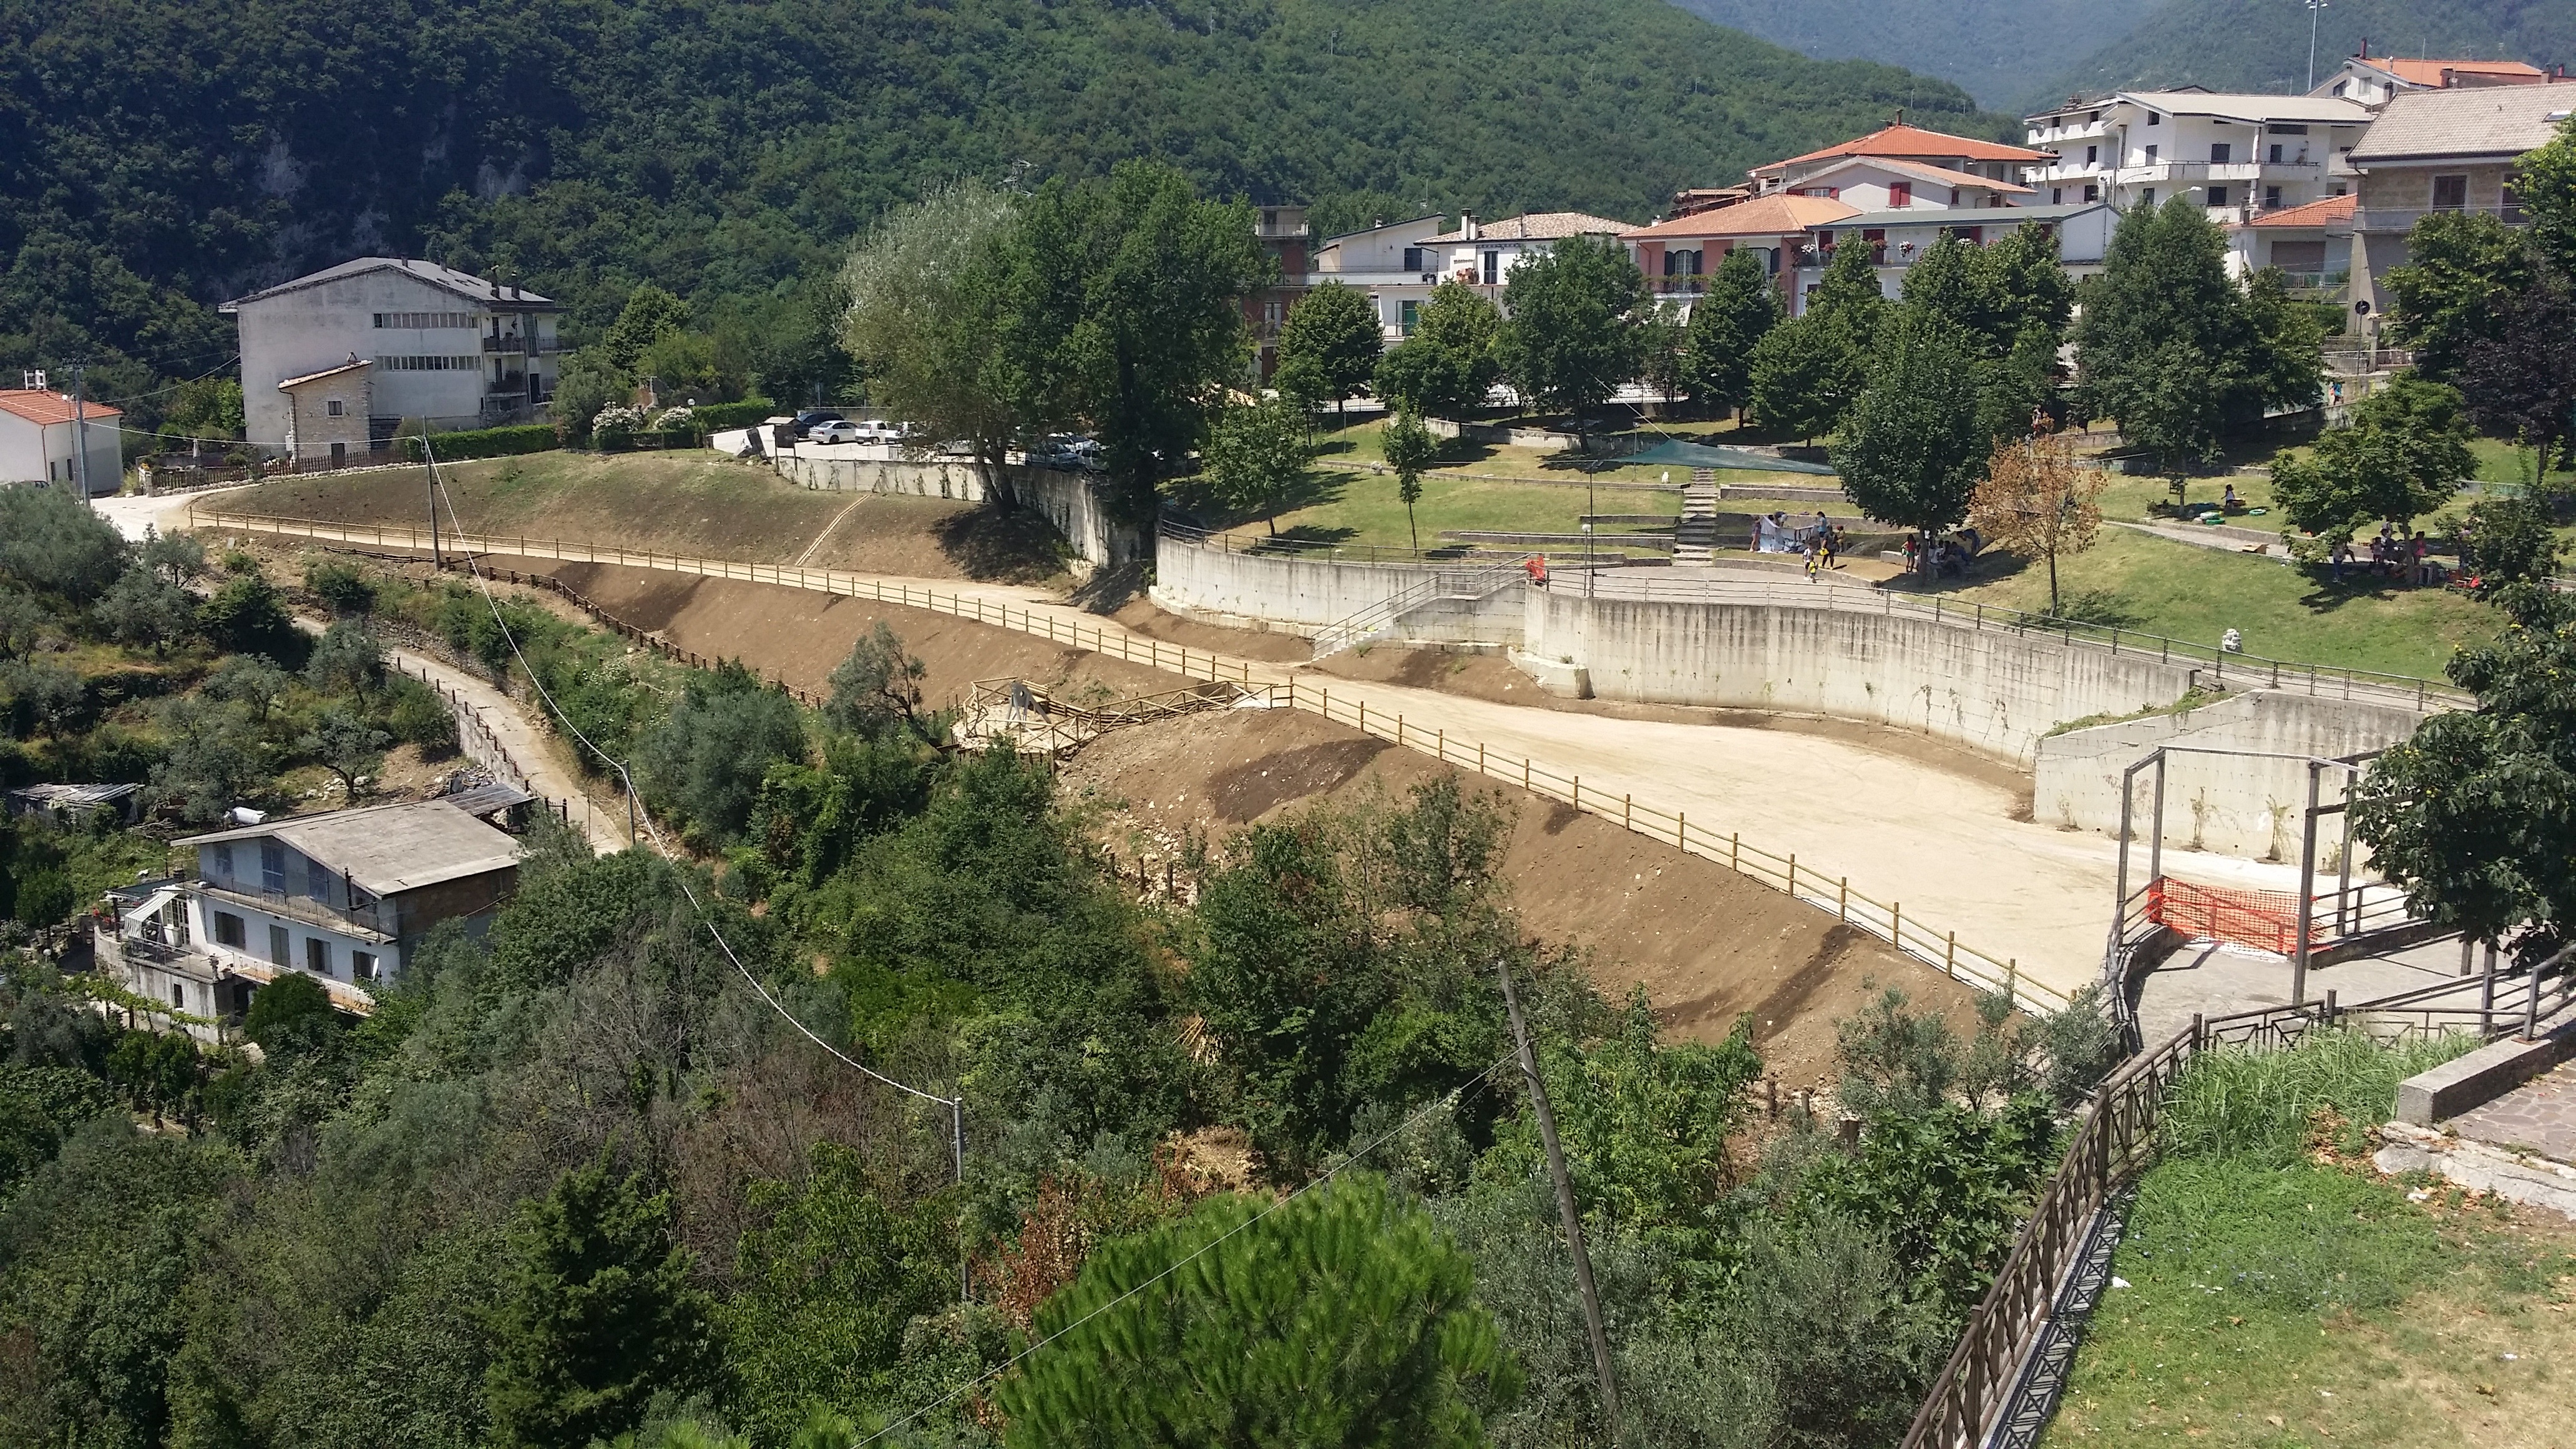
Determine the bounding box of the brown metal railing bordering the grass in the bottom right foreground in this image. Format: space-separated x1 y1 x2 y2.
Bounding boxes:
1904 972 2576 1449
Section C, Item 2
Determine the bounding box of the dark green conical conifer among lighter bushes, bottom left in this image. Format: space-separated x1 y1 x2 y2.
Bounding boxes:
484 1150 713 1449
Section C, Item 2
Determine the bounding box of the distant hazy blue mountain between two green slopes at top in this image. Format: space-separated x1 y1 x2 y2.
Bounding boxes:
1672 0 2143 109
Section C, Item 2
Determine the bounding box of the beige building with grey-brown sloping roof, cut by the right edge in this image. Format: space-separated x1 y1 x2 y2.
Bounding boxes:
2349 82 2576 330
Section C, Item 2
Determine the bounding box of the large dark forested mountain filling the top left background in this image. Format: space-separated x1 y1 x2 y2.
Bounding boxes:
0 0 1999 417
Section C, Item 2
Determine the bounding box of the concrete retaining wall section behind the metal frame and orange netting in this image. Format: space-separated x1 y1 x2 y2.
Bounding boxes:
2030 688 2424 866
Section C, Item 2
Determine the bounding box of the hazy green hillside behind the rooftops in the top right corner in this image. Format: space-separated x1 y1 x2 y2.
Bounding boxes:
2029 0 2576 105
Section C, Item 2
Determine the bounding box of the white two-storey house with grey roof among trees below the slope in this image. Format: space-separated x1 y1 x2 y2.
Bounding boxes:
95 797 525 1037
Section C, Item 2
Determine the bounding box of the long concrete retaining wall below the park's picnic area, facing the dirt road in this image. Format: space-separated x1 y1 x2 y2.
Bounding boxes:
1525 588 2192 763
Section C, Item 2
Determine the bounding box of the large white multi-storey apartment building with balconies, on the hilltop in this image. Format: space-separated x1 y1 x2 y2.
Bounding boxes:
2025 87 2370 227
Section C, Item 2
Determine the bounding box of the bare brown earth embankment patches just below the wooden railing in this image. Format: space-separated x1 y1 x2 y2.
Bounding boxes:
492 560 1973 1088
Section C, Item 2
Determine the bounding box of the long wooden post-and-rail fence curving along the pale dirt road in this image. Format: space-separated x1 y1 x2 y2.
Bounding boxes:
196 510 2066 1011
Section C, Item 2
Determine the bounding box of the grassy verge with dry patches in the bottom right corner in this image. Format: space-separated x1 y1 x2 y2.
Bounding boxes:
2046 1034 2576 1449
